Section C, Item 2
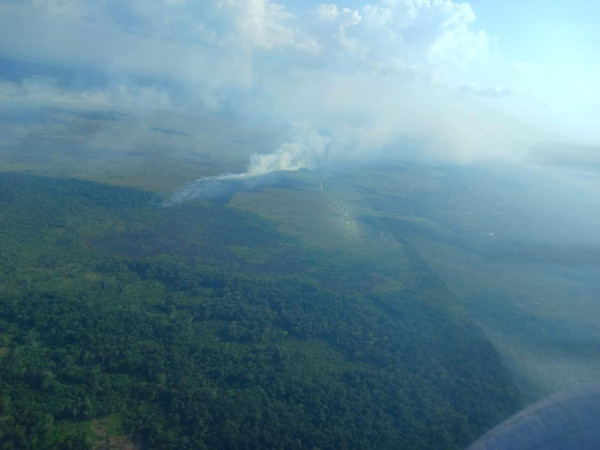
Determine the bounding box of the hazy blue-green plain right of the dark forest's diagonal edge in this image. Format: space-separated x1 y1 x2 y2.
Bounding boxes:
342 166 600 402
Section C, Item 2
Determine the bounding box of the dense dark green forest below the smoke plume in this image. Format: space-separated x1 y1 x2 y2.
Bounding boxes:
0 173 519 449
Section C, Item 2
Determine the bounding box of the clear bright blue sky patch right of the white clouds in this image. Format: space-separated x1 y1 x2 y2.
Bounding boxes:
472 0 600 105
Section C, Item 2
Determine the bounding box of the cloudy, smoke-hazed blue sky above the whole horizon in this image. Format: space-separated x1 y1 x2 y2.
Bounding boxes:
0 0 600 174
